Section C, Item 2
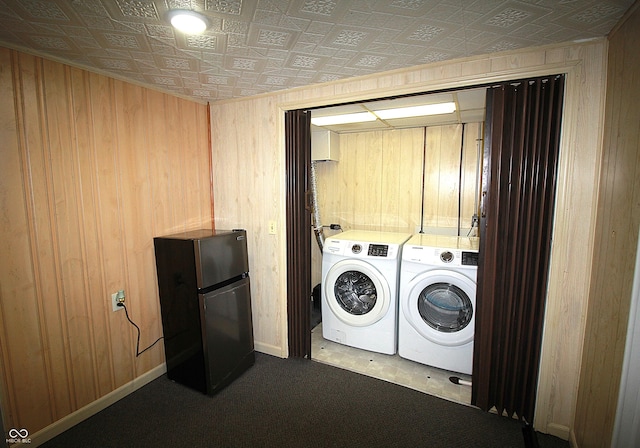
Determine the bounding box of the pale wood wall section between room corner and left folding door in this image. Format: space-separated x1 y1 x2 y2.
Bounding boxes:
211 95 288 357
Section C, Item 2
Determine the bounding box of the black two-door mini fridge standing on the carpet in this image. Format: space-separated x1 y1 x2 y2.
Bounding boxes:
153 229 255 395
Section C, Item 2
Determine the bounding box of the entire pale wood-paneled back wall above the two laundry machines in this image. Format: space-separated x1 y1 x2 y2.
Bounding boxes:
316 123 482 235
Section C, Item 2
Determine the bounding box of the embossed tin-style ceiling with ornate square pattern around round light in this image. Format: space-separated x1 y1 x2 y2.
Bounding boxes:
0 0 633 101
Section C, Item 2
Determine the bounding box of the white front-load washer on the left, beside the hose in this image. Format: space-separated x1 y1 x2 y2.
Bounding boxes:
322 230 411 355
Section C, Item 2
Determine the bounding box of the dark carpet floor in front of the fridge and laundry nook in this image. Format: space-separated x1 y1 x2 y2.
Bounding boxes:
42 353 569 448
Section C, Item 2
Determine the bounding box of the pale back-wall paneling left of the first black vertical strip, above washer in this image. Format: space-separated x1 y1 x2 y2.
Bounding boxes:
316 128 424 233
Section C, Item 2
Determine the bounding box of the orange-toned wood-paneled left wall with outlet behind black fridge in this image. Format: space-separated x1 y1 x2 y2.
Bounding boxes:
0 48 212 435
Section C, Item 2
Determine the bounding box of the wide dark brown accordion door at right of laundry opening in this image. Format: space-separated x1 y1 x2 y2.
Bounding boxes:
471 75 564 422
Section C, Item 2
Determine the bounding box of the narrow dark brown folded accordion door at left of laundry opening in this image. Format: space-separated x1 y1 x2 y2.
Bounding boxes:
285 110 311 359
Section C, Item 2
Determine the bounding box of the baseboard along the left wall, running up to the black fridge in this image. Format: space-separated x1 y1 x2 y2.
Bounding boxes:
28 363 167 447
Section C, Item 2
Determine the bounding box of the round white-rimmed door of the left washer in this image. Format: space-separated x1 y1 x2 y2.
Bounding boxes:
322 259 391 327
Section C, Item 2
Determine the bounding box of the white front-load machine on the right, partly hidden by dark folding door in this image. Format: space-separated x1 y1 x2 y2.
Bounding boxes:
398 234 479 375
